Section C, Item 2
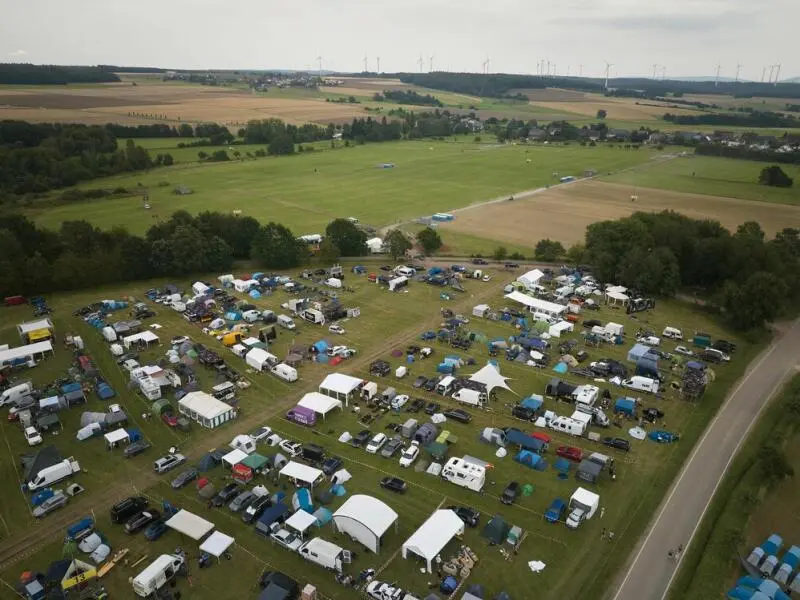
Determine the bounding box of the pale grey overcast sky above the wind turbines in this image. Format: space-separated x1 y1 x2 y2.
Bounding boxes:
0 0 800 80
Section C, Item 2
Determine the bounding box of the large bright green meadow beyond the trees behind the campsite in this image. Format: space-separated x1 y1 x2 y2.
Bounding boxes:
29 138 659 235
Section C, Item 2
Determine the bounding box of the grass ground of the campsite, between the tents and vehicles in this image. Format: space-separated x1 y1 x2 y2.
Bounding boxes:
0 262 757 600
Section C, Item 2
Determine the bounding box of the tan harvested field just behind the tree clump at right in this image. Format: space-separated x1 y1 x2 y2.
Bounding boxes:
440 181 800 246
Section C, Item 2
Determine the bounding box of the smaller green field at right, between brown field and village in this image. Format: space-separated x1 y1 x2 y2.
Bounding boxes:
605 155 800 205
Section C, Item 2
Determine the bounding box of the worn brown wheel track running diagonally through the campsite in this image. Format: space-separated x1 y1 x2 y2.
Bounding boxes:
0 285 504 571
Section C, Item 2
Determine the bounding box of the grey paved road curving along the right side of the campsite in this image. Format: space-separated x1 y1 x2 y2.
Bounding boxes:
611 320 800 600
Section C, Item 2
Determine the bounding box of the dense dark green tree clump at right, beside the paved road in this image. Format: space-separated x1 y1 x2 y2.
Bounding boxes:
570 211 800 330
